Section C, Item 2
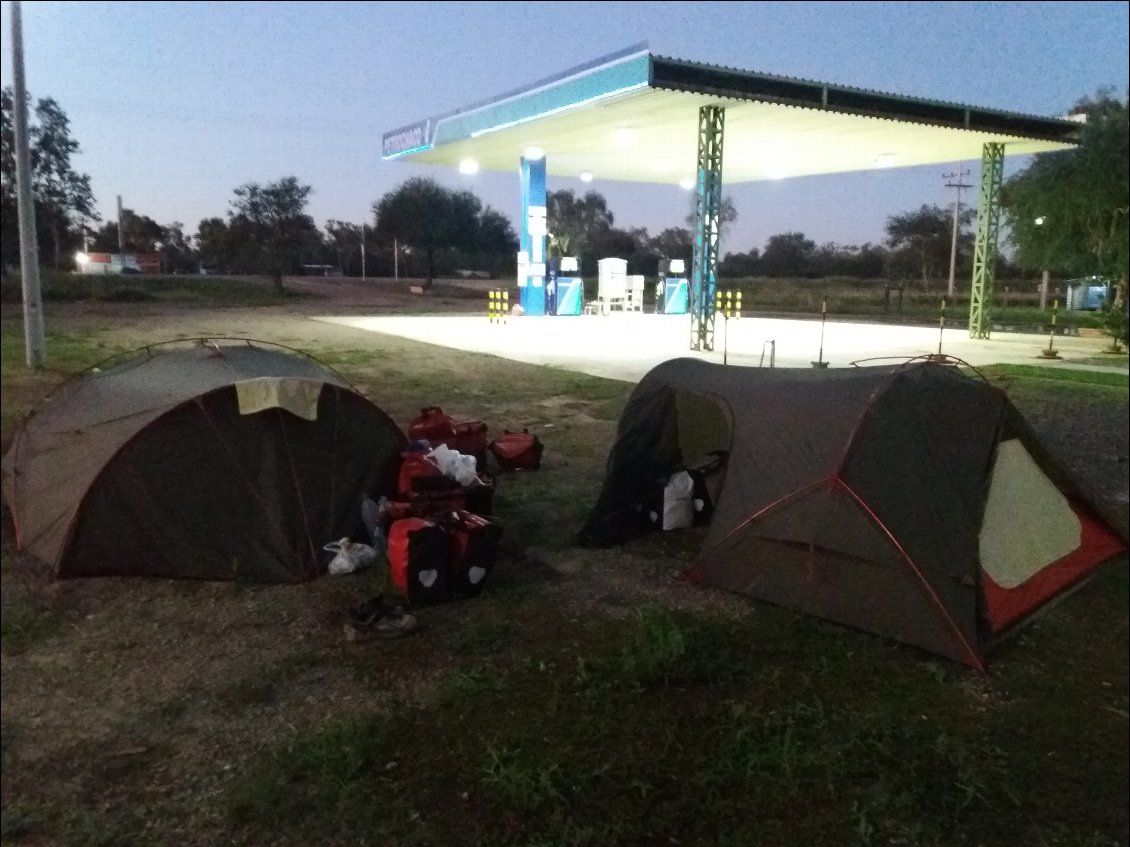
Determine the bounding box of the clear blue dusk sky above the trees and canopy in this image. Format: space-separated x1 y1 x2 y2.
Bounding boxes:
0 0 1130 252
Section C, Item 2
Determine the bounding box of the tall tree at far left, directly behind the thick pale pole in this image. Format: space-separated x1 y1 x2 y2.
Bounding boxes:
0 88 101 268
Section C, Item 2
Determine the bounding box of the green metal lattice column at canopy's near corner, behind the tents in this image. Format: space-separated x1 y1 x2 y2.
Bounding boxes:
690 106 725 351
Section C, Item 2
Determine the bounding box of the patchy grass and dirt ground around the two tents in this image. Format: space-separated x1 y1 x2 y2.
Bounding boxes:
0 285 1130 847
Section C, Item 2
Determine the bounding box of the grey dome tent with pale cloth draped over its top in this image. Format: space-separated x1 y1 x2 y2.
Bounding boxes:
3 339 407 582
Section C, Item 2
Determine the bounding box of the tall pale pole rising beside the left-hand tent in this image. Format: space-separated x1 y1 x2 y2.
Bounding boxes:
11 0 46 368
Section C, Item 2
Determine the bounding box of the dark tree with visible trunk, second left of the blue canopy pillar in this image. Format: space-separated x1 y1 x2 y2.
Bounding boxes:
228 176 320 294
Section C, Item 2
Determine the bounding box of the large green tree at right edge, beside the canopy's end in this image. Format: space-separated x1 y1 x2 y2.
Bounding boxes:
1001 90 1130 280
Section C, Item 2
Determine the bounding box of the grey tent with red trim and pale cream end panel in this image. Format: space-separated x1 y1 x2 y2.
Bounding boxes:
580 358 1127 667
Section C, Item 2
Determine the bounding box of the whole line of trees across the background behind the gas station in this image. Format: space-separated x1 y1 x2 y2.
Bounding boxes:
0 89 1130 298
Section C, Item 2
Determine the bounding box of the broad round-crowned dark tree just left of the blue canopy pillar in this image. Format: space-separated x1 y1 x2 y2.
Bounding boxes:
373 176 483 288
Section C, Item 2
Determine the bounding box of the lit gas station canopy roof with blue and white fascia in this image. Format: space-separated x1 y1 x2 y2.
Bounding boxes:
382 45 1080 182
